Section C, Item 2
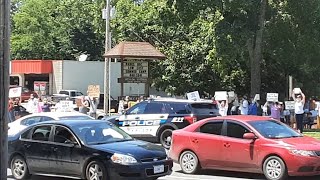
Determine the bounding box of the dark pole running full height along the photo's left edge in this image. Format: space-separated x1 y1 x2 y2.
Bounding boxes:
0 0 10 179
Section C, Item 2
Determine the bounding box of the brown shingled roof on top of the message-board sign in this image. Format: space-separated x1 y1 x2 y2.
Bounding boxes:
104 41 166 60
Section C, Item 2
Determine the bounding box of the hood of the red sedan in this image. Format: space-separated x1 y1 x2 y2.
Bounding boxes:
277 136 320 151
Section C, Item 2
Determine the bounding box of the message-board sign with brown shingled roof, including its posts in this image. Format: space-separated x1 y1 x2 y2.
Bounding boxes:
104 41 166 96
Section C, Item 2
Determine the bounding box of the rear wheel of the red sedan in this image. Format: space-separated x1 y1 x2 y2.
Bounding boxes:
179 151 200 174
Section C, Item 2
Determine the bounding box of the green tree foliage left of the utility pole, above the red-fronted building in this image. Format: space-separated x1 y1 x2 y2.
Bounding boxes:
12 0 104 60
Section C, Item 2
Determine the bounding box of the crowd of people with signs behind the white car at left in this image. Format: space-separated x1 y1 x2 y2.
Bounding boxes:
8 94 99 122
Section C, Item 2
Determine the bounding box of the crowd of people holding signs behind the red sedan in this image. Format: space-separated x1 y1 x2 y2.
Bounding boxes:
212 92 318 133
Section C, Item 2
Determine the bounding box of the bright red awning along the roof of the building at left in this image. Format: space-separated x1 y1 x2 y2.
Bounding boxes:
11 60 53 74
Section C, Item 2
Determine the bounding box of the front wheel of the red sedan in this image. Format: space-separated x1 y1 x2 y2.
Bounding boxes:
263 156 288 180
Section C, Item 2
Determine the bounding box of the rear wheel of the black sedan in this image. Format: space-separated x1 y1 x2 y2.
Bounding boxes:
10 155 31 180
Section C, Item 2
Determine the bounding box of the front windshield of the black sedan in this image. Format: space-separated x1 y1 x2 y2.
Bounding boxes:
72 121 133 145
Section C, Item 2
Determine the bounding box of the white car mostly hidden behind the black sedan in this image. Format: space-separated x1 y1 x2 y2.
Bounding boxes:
8 112 93 135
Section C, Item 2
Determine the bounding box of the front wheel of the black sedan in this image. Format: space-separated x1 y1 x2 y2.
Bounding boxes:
86 161 107 180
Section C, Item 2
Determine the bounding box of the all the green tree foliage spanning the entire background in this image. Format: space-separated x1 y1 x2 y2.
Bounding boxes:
12 0 320 97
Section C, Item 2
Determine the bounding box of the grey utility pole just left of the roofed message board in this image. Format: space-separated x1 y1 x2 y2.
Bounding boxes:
103 0 111 114
